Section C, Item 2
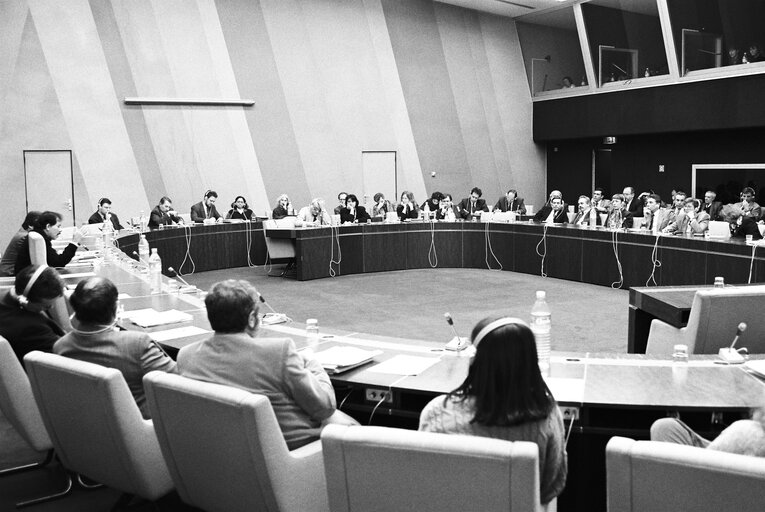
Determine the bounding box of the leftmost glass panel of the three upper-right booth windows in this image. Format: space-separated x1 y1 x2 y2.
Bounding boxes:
516 7 587 96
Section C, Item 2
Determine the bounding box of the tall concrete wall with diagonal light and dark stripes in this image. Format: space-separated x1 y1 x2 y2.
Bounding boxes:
0 0 545 246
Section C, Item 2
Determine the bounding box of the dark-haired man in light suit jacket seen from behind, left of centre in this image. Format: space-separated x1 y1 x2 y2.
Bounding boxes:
178 280 357 450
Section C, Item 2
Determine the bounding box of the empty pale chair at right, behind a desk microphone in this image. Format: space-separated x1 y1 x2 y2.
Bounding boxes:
646 286 765 355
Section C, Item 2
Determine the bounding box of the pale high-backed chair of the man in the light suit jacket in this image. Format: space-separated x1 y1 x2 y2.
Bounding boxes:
144 372 328 512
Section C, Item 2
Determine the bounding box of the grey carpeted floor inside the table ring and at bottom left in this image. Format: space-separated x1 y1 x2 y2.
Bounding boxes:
0 267 628 511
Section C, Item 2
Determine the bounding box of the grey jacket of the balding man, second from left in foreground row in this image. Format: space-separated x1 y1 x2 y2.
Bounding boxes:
53 317 178 418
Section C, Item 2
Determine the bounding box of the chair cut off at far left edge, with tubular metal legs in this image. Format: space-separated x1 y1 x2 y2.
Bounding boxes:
0 336 72 507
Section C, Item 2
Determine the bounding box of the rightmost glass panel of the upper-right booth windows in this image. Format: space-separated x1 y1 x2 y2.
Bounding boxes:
667 0 765 75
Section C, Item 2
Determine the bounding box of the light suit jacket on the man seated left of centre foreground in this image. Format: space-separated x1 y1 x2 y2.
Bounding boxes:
178 333 336 450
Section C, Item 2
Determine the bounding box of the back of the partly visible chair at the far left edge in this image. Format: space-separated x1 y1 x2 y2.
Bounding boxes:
0 336 53 452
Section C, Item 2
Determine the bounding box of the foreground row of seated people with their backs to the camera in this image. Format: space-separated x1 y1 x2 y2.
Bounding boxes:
5 266 765 504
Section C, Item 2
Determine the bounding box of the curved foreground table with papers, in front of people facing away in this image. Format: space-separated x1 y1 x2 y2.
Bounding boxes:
53 257 765 511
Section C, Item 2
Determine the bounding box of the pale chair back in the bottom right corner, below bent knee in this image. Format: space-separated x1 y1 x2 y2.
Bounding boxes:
606 437 765 512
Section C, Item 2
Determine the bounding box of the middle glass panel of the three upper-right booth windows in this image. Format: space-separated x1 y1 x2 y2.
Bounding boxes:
582 0 669 86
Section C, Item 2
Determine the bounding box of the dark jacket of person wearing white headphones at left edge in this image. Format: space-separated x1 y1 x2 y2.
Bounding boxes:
0 290 64 365
